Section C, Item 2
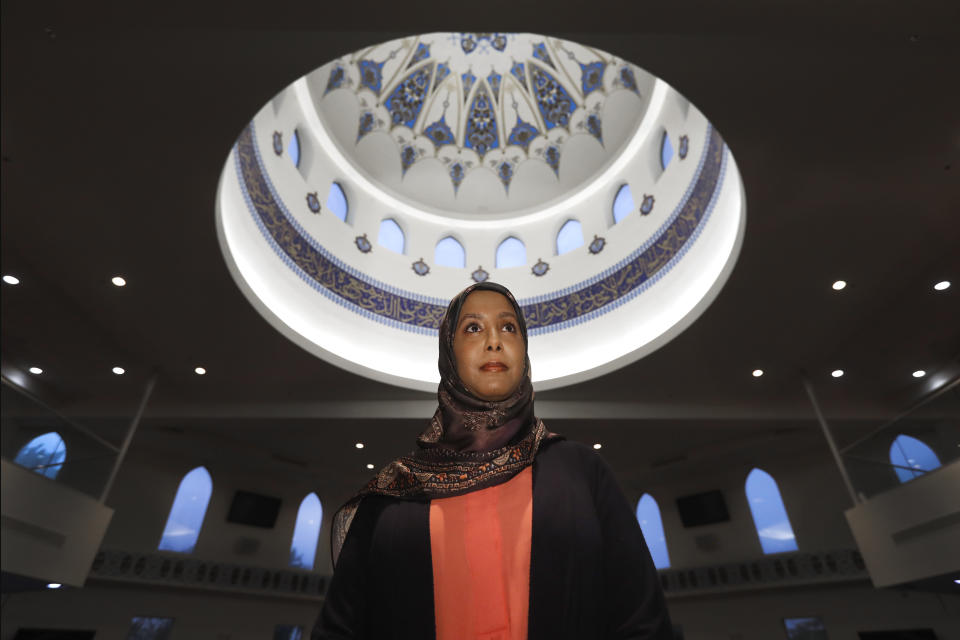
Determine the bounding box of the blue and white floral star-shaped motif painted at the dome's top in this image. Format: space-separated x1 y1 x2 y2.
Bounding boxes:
324 33 643 194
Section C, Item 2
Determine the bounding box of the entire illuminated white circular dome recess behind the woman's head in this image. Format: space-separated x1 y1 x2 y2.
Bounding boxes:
217 33 746 390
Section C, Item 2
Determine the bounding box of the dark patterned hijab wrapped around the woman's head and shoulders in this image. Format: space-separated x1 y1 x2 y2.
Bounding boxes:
330 282 562 565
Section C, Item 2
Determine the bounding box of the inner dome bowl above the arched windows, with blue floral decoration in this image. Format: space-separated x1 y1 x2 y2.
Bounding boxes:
316 33 653 216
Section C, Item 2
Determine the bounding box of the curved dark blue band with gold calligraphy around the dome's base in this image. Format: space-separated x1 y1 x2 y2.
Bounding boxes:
234 123 728 336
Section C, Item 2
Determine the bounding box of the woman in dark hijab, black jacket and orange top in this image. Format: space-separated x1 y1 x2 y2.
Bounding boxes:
313 283 672 640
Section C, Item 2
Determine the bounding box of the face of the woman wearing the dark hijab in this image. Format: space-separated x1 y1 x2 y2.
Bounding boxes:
453 290 526 401
